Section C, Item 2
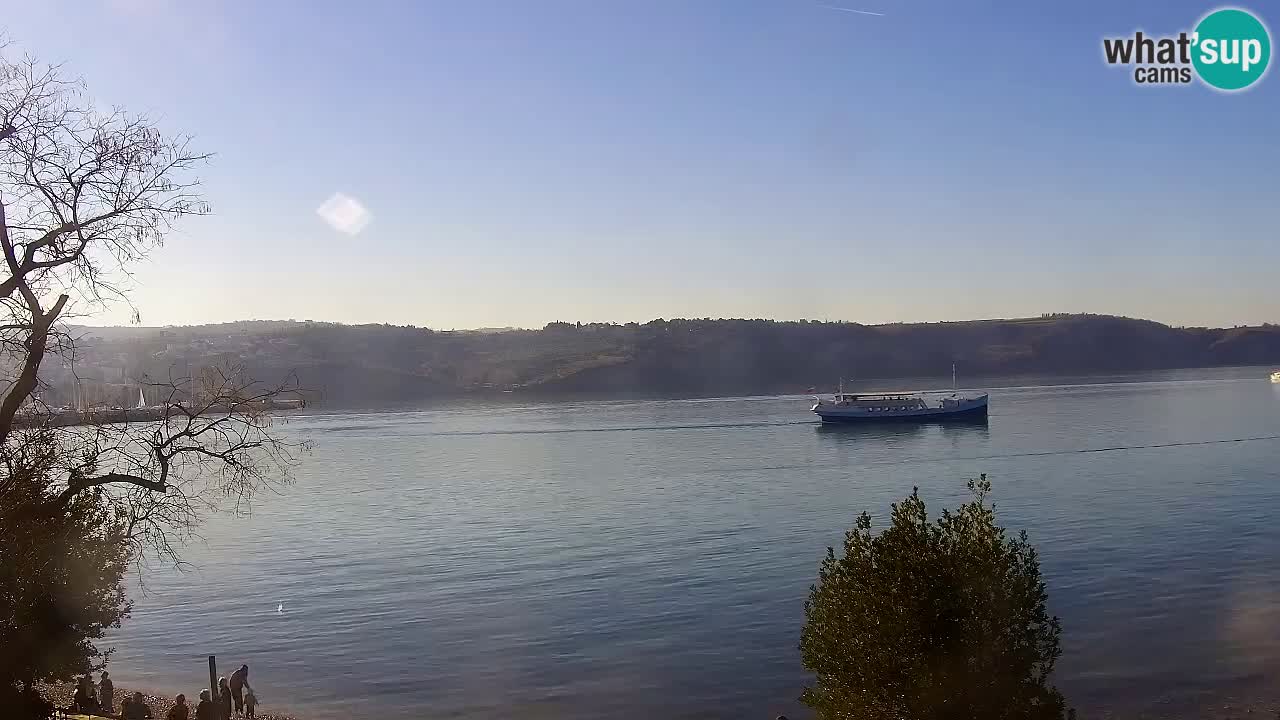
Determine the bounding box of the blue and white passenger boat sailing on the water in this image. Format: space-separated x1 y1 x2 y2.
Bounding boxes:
812 366 987 423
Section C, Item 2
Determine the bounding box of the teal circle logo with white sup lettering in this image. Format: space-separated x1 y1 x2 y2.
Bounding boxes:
1192 8 1271 91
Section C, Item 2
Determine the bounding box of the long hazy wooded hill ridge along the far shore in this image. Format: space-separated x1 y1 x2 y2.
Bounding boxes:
57 315 1280 407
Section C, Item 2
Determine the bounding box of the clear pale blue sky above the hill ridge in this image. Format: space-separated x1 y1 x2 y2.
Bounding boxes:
0 0 1280 329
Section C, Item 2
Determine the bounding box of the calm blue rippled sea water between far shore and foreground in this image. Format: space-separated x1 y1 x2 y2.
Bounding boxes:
110 369 1280 719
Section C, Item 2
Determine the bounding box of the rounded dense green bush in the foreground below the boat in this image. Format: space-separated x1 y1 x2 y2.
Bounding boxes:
800 475 1071 720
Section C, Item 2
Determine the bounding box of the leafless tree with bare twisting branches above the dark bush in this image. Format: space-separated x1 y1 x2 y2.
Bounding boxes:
0 49 307 560
